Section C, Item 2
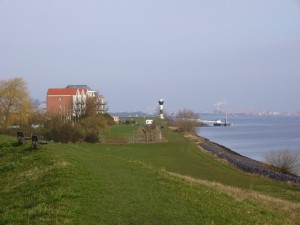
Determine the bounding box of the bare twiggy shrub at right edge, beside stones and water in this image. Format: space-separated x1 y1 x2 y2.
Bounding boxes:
265 149 300 174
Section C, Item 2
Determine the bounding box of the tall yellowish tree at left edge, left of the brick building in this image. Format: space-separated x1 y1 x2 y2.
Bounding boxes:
0 78 34 127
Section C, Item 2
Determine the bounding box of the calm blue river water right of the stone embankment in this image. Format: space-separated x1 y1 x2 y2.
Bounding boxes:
198 114 300 161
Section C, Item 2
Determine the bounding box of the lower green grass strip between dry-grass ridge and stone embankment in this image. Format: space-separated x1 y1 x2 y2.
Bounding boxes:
100 125 300 202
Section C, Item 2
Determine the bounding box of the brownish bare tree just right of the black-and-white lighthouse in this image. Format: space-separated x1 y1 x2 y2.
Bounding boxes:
176 109 199 133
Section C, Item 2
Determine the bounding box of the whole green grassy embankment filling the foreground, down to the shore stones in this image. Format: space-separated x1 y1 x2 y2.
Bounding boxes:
0 121 300 225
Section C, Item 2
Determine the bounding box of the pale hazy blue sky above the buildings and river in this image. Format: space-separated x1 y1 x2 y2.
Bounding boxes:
0 0 300 113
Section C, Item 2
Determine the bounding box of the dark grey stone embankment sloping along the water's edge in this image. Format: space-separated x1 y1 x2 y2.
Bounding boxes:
198 138 300 184
